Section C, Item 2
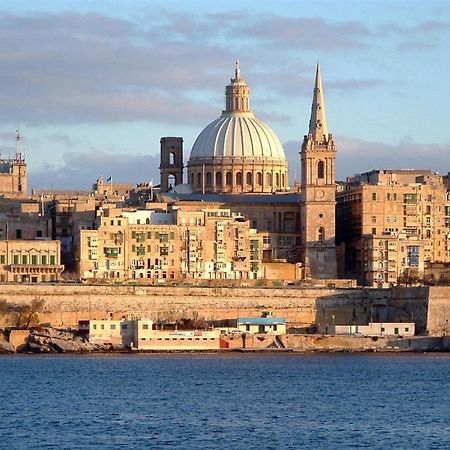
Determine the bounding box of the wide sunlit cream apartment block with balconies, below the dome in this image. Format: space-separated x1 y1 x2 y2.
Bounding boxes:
77 209 262 282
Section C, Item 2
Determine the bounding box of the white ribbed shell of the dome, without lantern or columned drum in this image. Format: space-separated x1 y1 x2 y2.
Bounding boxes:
190 112 286 161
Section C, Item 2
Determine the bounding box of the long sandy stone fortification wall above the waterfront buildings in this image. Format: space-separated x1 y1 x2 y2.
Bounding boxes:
0 284 450 336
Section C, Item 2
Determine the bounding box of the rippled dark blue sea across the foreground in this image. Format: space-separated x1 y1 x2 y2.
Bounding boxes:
0 354 450 449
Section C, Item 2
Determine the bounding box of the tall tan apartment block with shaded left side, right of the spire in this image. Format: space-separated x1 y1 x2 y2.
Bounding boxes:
336 170 450 286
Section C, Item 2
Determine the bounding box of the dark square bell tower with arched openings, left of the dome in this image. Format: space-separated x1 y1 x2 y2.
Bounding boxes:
159 137 183 192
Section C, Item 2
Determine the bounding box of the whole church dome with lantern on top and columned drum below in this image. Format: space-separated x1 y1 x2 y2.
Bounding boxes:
188 61 287 193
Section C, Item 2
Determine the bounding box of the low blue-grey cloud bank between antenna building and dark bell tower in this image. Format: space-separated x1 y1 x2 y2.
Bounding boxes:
28 150 159 190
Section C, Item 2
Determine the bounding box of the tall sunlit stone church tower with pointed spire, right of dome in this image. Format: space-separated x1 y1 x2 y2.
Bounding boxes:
300 64 337 278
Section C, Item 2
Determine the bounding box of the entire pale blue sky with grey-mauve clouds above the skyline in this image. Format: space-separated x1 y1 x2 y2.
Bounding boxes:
0 0 450 189
